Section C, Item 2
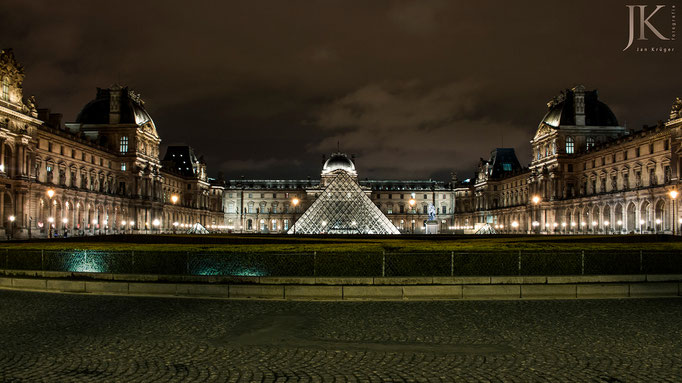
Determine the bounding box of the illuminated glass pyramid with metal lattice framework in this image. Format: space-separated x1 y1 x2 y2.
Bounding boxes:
288 170 400 234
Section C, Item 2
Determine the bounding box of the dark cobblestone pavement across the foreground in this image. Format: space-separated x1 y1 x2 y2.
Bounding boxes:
0 290 682 382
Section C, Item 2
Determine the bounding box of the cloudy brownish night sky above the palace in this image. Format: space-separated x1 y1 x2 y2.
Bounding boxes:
0 0 682 179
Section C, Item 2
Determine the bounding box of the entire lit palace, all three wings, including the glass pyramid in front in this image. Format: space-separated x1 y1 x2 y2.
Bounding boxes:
0 49 682 238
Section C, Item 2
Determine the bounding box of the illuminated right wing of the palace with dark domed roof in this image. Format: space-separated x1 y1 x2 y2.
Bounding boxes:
455 86 682 234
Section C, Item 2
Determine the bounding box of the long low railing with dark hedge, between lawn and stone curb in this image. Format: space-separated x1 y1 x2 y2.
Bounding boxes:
0 249 682 277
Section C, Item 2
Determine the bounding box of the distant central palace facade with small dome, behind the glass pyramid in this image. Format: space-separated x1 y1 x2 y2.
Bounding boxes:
225 153 455 234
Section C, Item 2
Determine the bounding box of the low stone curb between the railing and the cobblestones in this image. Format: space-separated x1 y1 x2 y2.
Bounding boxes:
0 276 682 300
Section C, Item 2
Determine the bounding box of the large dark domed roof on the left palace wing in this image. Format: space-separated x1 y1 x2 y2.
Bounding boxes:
76 85 153 125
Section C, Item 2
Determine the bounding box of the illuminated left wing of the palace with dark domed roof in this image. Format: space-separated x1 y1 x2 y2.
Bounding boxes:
0 50 224 237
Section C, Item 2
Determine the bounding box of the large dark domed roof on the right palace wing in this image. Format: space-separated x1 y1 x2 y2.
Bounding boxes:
540 85 619 128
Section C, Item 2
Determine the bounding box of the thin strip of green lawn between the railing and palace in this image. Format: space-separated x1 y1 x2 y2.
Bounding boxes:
0 234 682 253
